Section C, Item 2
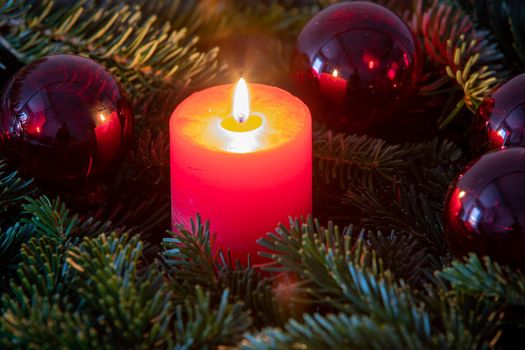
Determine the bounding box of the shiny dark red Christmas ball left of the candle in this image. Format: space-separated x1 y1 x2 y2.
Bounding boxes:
0 55 134 187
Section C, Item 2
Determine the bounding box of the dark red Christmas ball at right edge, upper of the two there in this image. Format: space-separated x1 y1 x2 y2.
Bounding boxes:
470 74 525 155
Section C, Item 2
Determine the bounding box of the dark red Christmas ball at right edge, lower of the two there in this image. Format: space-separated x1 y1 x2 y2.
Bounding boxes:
445 147 525 271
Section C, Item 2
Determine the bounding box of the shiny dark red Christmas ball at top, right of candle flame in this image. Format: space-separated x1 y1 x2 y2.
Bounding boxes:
292 1 421 132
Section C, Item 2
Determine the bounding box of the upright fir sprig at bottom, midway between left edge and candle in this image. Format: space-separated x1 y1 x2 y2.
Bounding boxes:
67 234 173 348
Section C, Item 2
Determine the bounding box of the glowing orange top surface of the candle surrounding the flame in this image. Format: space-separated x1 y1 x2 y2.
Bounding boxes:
170 83 312 153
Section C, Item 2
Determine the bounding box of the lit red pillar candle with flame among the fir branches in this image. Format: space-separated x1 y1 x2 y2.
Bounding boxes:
170 79 312 263
